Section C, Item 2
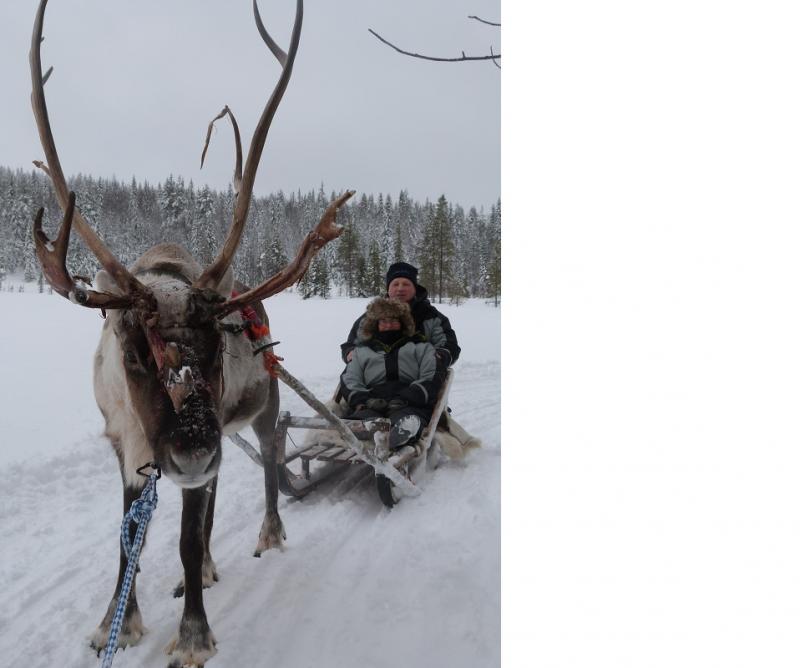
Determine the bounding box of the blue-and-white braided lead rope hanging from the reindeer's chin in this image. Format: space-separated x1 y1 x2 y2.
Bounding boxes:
102 472 160 668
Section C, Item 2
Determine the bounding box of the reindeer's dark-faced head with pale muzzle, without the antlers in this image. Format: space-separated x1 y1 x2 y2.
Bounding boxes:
95 258 230 487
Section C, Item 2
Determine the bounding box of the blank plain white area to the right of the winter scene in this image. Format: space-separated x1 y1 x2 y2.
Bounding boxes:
510 1 800 668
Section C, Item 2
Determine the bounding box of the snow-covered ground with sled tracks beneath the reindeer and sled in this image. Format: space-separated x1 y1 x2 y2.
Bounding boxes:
0 287 500 668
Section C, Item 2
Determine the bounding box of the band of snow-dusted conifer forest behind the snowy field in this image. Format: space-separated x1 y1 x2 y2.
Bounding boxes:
0 167 500 305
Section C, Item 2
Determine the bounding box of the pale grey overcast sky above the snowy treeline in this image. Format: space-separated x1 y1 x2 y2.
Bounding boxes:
0 0 501 209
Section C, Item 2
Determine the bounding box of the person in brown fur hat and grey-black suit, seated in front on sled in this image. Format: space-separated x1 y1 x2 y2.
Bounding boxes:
341 297 440 449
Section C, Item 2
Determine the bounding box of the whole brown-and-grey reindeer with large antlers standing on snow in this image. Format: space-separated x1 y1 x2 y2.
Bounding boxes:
30 0 353 667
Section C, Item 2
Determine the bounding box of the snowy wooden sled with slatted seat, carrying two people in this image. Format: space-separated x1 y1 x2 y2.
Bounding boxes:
231 369 453 508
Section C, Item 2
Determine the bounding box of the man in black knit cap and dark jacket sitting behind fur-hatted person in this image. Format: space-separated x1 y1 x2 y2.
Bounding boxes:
341 262 461 379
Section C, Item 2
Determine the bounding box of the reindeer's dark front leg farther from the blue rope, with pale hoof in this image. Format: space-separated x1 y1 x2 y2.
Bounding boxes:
166 485 217 668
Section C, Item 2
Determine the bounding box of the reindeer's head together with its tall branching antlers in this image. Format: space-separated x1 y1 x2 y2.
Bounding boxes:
30 0 353 487
